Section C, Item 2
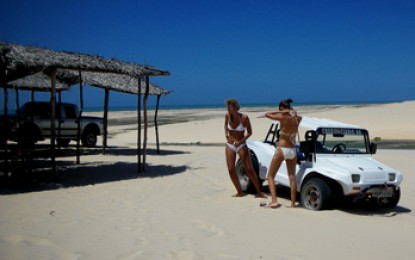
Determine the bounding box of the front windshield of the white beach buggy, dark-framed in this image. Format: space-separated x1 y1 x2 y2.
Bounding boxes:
316 128 370 154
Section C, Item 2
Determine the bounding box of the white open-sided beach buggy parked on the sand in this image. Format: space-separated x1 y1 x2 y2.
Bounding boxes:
236 117 402 210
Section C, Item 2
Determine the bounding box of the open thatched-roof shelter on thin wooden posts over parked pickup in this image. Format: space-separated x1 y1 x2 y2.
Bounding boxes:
0 42 170 174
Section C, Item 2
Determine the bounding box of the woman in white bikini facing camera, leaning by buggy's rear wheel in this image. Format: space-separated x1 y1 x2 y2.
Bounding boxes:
225 99 267 198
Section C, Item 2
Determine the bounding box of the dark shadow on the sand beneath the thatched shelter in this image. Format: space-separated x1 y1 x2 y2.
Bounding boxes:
0 147 188 194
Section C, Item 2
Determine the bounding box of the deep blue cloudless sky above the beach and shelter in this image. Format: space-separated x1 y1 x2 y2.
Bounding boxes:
0 0 415 106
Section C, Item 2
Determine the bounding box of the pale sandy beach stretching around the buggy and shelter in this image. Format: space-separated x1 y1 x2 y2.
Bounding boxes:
0 101 415 259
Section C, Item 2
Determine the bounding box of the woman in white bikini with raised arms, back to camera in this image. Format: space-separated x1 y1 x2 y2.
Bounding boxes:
265 99 302 208
